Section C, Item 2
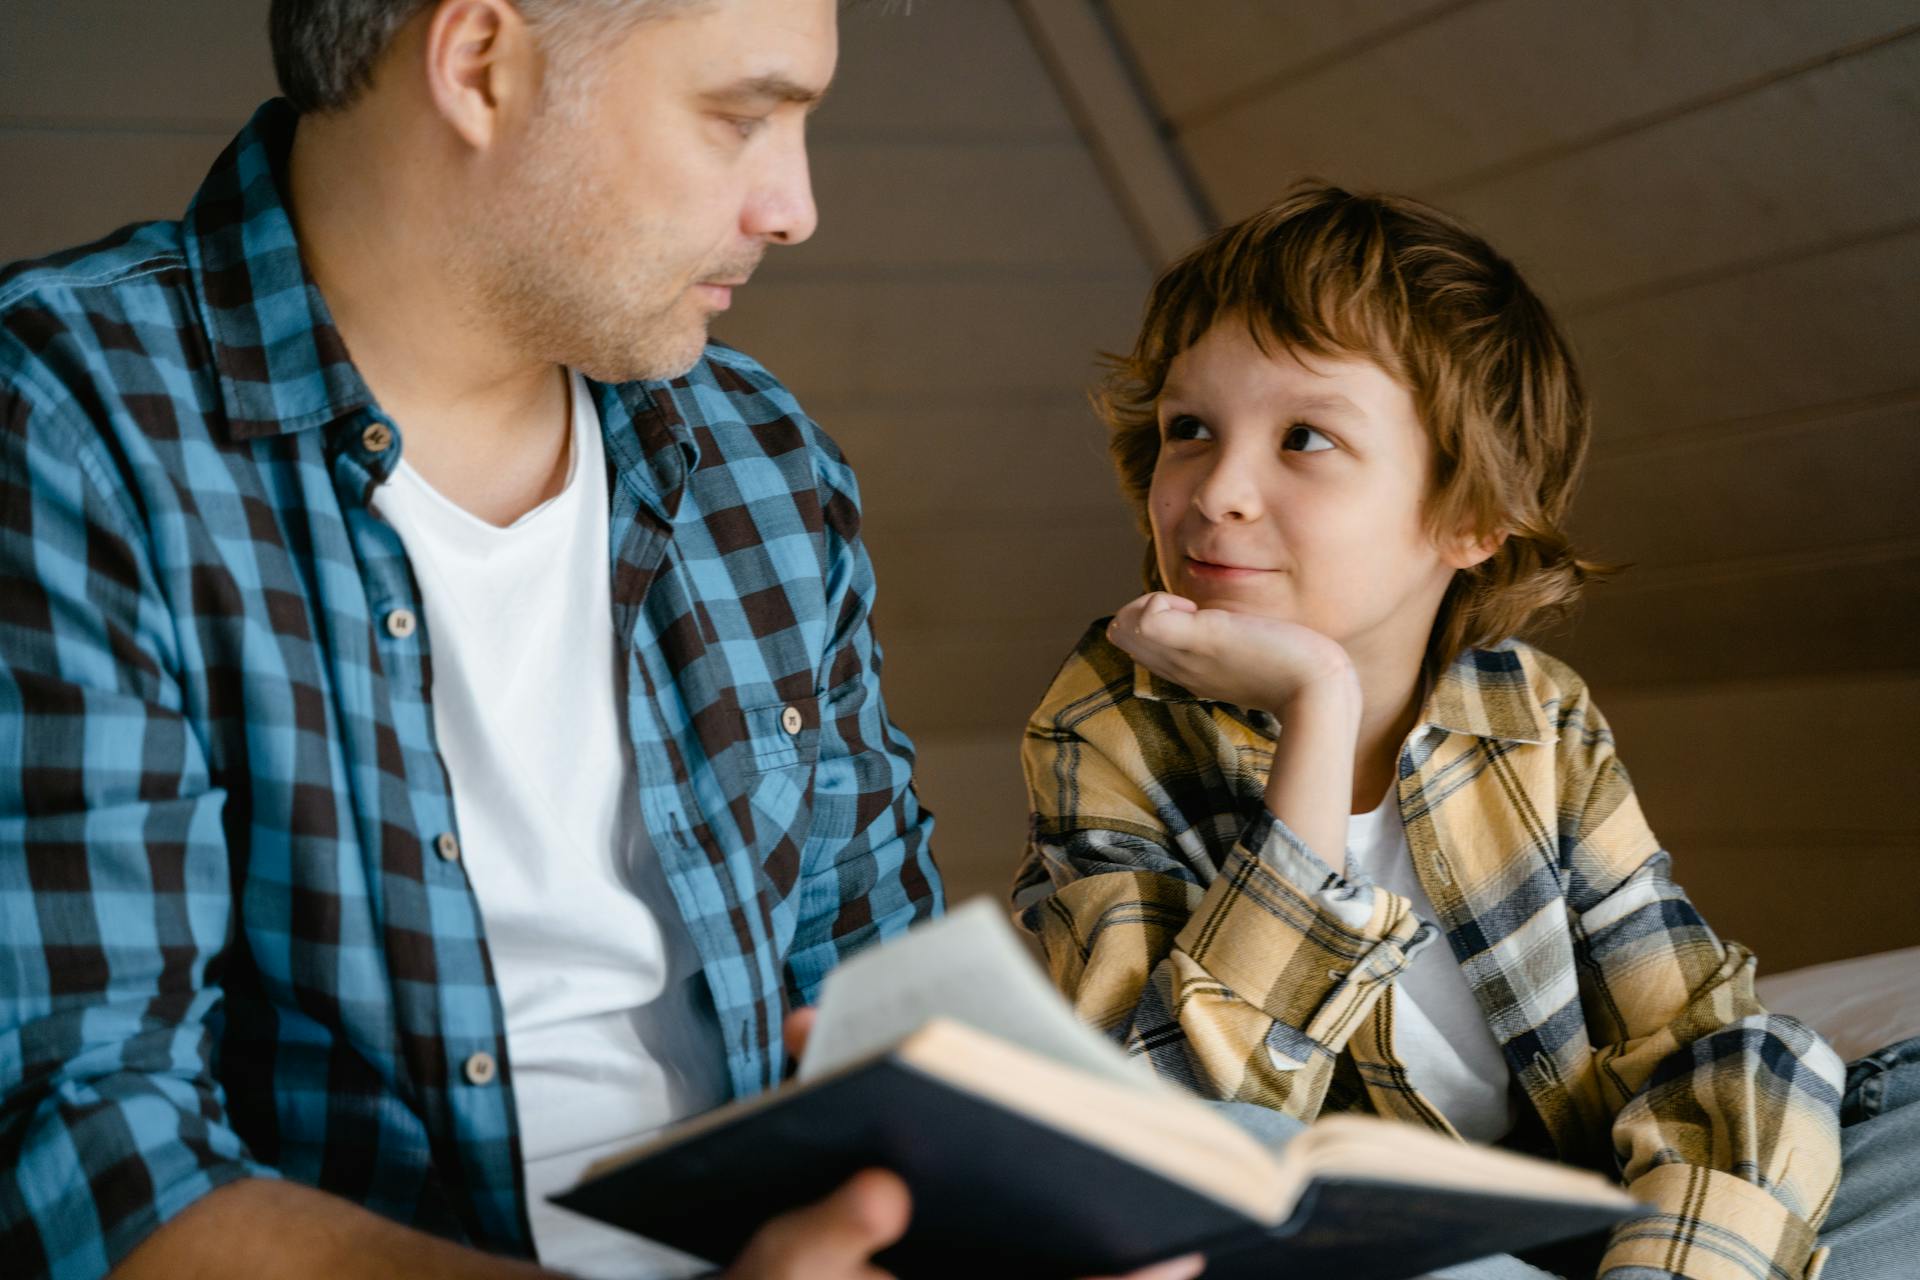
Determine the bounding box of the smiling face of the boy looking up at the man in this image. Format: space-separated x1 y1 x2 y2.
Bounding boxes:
1148 315 1471 662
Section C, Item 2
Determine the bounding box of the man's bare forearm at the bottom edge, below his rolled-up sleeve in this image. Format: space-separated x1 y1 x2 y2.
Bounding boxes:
111 1178 553 1280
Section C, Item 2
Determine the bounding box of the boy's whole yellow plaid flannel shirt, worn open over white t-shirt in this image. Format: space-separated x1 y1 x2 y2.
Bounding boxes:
1014 620 1843 1280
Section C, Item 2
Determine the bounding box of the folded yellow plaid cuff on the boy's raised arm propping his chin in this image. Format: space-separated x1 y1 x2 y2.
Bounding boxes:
1175 808 1436 1048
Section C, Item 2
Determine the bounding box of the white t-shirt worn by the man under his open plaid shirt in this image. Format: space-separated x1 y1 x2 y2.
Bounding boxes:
374 374 728 1276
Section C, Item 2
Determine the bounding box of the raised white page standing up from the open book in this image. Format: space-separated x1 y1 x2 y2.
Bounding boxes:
801 898 1169 1090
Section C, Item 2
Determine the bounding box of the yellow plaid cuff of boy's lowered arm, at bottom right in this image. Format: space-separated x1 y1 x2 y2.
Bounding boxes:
1599 1165 1826 1280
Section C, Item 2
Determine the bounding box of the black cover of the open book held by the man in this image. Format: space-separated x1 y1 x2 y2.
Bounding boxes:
555 1057 1622 1280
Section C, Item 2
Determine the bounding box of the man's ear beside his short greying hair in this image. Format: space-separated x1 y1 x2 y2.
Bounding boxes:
424 0 540 150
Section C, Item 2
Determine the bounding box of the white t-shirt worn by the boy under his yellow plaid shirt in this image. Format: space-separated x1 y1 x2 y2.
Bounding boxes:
1346 787 1513 1142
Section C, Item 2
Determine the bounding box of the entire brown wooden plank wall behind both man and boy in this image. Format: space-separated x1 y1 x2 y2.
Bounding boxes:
0 0 1920 969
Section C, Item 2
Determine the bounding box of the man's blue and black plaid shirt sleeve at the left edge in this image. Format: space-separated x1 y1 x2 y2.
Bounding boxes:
0 370 273 1280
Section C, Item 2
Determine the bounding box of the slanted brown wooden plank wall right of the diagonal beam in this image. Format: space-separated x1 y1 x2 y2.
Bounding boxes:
1106 0 1920 969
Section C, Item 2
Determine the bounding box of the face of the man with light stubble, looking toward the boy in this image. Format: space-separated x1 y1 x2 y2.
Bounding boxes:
463 0 837 382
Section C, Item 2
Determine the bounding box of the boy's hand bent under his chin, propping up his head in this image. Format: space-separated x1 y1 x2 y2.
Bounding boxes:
1106 591 1359 718
